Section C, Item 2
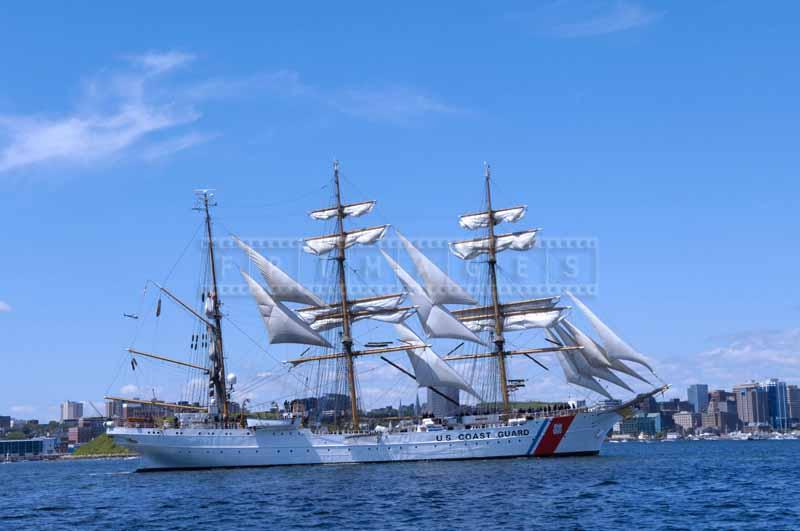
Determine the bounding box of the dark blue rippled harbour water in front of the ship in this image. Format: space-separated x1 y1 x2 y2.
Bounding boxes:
0 441 800 530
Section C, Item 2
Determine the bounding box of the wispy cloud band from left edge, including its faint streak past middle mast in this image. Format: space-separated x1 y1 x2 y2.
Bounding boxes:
0 51 462 173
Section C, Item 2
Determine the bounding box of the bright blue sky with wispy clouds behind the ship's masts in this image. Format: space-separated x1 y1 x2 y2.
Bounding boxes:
0 0 800 420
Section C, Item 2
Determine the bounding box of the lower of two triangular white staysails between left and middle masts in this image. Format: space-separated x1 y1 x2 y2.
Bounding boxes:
241 271 331 347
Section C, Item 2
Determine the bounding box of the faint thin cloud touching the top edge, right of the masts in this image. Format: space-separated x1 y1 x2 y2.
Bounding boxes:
520 0 664 38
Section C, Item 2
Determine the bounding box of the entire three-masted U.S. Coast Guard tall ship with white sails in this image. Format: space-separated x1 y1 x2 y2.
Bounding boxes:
106 162 667 471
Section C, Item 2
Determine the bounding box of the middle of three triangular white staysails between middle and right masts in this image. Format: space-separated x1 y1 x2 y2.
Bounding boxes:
381 249 484 345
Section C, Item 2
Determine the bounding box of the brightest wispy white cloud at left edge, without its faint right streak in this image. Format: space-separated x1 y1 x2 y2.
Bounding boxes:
0 52 201 172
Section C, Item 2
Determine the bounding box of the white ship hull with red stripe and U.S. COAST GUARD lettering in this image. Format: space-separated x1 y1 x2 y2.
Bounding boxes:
108 411 621 471
